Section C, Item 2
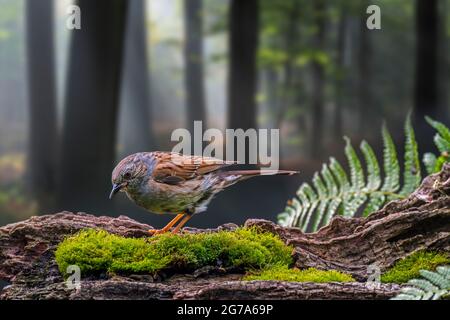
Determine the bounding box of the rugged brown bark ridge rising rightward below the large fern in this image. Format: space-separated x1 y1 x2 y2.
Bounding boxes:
246 165 450 280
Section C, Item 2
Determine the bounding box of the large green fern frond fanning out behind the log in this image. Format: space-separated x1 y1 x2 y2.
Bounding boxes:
278 116 421 232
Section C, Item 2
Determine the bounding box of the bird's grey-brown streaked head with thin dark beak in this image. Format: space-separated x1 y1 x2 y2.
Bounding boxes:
109 154 147 199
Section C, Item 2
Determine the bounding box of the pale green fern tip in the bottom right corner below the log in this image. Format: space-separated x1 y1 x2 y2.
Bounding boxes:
391 266 450 300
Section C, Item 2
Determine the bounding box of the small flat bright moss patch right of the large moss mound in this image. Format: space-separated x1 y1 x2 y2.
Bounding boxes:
243 265 355 283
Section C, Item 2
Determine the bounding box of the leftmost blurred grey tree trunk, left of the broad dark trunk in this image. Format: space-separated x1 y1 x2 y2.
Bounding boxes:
26 0 57 214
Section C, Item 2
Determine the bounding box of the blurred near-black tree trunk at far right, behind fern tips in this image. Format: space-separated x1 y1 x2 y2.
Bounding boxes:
414 0 439 151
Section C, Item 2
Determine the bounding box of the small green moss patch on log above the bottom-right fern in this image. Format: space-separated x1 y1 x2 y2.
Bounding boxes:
381 251 450 284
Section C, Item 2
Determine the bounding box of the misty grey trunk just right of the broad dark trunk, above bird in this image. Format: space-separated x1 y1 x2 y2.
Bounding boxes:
120 0 155 155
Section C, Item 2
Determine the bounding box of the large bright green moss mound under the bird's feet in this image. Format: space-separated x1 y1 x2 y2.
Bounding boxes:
55 228 292 274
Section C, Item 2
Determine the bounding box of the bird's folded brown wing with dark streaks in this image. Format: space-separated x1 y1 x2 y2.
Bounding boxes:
153 152 236 184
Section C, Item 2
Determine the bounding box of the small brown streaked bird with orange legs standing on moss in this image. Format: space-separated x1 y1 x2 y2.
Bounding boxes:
109 151 297 234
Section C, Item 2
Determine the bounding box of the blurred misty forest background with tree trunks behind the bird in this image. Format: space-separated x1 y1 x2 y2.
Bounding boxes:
0 0 450 227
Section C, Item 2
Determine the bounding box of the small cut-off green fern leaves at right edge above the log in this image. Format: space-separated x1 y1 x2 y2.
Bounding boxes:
422 117 450 174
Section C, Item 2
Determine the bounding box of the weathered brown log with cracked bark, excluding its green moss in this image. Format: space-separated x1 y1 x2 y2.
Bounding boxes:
0 165 450 299
